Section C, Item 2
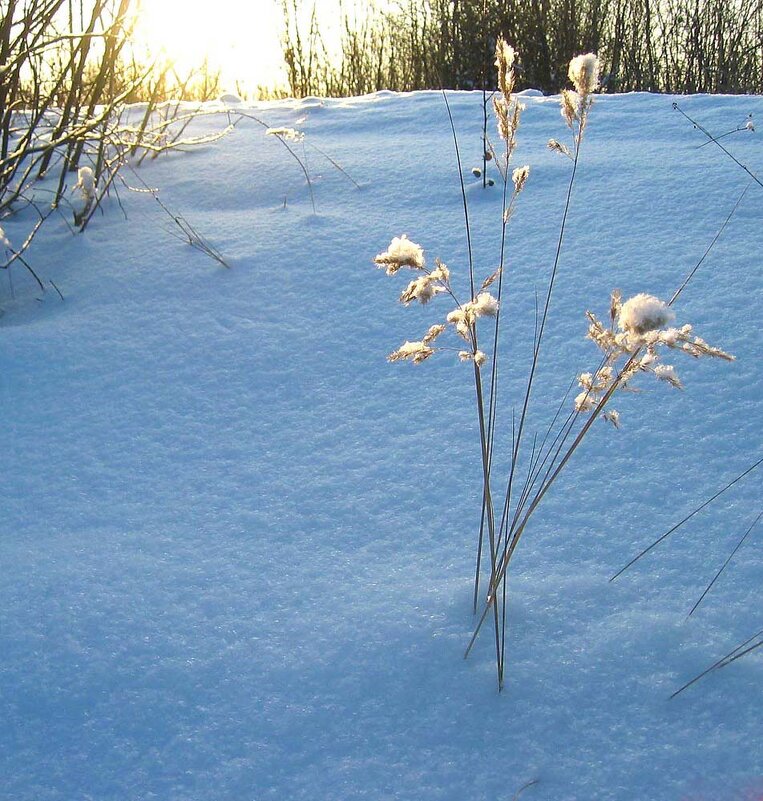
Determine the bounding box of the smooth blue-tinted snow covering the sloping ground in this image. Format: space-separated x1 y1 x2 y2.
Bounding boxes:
0 93 763 801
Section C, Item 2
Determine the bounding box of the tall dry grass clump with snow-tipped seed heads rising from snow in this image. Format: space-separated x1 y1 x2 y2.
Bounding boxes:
374 39 733 689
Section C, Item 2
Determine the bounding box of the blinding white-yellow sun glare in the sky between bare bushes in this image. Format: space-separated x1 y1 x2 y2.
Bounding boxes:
135 0 284 93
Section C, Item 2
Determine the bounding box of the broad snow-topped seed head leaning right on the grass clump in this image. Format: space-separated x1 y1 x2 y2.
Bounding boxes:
575 290 734 426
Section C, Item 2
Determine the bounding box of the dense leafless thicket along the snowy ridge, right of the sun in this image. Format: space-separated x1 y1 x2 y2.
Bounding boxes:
281 0 763 97
